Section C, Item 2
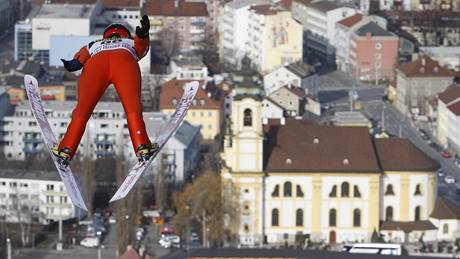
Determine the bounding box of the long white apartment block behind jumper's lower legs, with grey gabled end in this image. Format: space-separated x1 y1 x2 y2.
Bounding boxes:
1 101 200 184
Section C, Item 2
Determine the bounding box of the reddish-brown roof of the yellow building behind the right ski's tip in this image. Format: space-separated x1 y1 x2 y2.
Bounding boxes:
160 79 224 110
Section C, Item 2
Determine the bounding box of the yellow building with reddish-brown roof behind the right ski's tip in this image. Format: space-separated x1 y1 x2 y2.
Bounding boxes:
160 79 224 140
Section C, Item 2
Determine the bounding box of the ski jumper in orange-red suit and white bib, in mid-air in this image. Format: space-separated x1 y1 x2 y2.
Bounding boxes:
52 15 158 164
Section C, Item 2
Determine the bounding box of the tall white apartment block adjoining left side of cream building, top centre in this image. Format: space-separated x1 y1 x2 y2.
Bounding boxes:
219 0 270 66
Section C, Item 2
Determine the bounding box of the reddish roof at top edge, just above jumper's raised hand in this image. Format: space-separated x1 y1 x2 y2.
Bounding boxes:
141 0 208 17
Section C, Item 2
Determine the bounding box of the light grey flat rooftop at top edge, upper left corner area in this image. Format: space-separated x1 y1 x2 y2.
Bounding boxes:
35 4 95 19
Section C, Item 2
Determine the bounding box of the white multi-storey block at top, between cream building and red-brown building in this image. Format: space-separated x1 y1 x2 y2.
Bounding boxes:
304 1 357 65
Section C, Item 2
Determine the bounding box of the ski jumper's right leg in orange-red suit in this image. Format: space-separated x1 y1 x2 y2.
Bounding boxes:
111 53 150 151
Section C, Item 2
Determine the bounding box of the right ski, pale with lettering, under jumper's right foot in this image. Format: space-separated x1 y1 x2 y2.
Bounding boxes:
109 81 199 202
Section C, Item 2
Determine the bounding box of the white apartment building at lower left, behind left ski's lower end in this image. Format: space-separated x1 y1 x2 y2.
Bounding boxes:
0 168 81 224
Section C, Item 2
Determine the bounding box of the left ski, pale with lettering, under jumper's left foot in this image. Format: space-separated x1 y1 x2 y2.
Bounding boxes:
24 75 88 211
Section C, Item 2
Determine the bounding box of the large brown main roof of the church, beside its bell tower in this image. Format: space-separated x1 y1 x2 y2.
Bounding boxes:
265 119 380 173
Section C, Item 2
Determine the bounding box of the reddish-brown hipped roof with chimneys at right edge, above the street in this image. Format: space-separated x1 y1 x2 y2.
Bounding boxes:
396 56 458 77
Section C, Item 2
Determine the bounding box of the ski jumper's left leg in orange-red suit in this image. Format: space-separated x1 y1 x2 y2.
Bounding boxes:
59 53 110 157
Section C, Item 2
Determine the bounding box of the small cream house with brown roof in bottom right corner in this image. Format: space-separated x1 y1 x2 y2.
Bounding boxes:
430 197 460 242
